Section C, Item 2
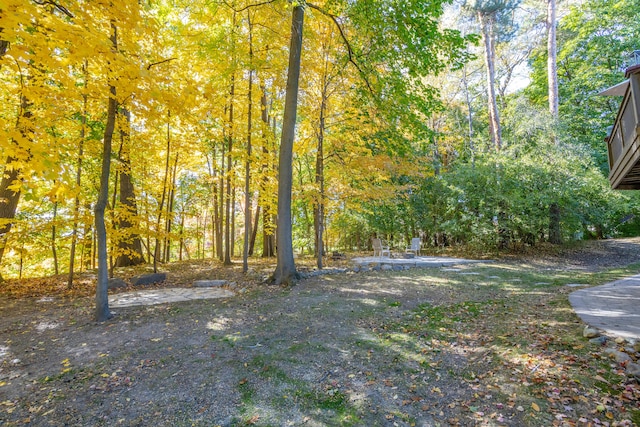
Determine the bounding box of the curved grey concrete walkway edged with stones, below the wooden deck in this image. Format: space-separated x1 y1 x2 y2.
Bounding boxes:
569 274 640 339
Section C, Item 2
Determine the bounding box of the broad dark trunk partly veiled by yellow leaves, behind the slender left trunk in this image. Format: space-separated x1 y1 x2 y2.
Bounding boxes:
115 108 145 267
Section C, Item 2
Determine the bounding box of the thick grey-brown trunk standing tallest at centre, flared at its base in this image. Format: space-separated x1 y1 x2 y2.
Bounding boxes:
273 4 304 285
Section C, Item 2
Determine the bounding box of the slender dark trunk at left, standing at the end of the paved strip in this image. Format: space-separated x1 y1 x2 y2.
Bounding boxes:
95 23 118 322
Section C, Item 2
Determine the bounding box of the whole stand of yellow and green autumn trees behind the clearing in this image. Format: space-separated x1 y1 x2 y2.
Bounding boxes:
0 0 640 286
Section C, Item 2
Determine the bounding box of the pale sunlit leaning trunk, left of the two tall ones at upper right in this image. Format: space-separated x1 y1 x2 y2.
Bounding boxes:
477 11 502 150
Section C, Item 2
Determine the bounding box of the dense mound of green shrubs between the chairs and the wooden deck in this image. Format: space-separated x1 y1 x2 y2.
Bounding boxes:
360 127 639 249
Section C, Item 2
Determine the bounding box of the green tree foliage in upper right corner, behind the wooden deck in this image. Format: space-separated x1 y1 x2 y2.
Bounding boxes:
527 0 640 173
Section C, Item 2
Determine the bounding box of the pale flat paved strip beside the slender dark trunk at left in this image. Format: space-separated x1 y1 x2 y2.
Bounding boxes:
109 287 235 308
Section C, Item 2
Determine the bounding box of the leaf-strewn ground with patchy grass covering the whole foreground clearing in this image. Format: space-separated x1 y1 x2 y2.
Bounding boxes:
0 241 640 426
